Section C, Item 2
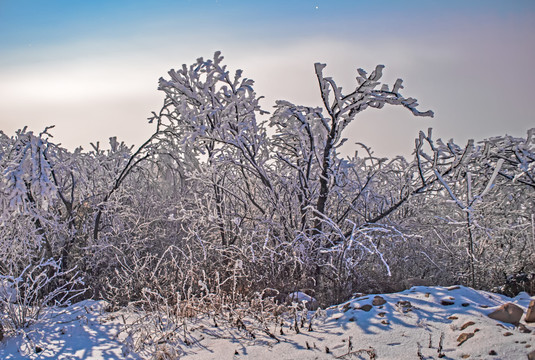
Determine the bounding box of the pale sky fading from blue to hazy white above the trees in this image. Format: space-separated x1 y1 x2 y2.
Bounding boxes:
0 0 535 157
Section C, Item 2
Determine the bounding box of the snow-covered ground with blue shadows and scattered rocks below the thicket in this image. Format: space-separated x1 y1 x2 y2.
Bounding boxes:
0 286 535 360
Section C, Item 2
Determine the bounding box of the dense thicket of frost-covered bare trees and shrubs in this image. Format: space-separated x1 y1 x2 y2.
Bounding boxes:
0 53 535 338
